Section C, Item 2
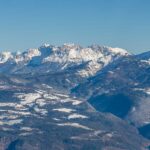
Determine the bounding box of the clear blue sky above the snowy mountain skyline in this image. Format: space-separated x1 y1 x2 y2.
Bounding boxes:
0 0 150 53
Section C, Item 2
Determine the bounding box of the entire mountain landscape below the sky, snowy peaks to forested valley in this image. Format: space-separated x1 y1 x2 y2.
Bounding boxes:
0 44 150 150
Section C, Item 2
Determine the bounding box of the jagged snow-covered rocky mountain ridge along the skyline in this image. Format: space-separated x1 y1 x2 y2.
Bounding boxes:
0 44 129 77
